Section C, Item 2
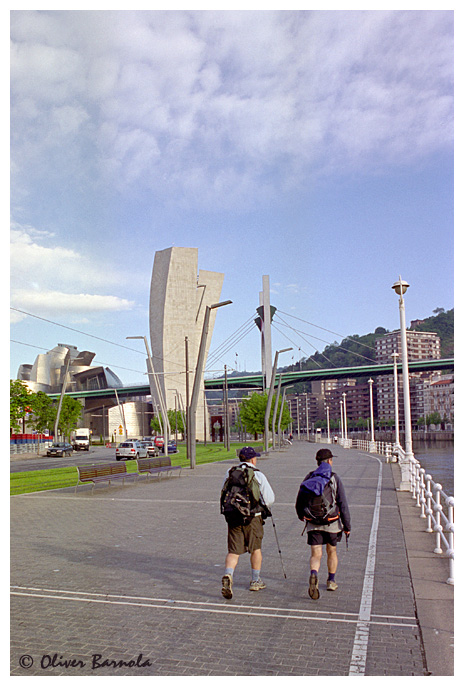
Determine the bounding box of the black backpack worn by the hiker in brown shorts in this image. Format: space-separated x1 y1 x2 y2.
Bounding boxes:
221 464 265 524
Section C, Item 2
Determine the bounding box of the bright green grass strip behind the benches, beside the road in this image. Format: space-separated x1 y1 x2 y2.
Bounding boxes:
10 443 252 495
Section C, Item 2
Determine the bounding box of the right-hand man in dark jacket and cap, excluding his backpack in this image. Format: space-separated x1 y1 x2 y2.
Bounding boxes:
295 448 351 600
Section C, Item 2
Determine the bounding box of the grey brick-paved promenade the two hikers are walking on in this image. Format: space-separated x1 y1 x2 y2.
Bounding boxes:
11 441 453 676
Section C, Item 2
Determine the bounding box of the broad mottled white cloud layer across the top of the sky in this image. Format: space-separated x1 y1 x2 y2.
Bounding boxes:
11 10 453 204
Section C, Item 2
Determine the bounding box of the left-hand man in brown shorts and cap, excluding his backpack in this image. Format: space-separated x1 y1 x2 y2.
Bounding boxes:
221 446 275 600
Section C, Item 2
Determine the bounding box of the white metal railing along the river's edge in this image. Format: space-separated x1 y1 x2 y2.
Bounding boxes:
346 438 454 585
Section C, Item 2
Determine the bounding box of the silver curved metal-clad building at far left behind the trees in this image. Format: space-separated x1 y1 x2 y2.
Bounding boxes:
17 343 122 393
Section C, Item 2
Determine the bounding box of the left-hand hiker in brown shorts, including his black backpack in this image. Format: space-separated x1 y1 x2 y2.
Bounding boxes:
221 446 275 600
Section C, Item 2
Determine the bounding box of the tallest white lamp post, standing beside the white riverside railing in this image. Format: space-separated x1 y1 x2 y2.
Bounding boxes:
392 276 414 491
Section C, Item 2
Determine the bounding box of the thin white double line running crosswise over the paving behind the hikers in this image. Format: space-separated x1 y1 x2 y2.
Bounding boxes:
11 586 416 628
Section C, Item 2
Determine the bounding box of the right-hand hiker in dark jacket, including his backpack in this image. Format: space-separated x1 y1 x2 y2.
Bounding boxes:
295 448 351 600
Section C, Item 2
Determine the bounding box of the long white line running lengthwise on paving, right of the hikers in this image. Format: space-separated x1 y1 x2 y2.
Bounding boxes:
348 457 382 676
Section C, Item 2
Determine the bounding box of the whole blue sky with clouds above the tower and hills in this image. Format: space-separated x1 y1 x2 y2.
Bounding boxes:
10 9 454 385
